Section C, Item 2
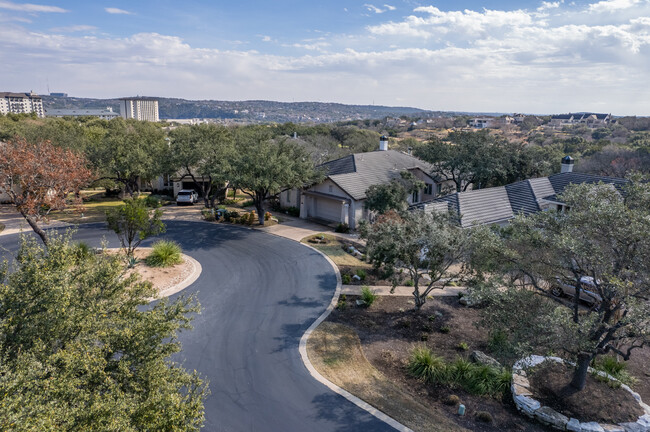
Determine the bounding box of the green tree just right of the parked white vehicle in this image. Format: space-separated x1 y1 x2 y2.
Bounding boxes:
168 125 235 207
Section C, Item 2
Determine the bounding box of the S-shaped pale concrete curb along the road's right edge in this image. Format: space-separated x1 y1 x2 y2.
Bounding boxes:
298 243 413 432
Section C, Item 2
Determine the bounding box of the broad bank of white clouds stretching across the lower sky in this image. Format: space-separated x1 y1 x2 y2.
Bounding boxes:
0 3 650 115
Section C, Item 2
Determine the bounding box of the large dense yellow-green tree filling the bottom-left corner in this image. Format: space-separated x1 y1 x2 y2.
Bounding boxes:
0 237 208 432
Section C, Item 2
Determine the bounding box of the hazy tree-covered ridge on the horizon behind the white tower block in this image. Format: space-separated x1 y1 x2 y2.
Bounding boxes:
43 96 444 123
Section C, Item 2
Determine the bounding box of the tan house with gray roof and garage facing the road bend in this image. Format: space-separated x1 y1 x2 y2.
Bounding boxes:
280 137 450 229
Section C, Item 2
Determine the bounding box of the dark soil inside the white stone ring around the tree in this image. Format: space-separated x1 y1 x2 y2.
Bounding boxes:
528 361 644 423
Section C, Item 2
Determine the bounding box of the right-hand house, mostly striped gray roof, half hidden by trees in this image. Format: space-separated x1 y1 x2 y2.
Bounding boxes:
411 156 627 228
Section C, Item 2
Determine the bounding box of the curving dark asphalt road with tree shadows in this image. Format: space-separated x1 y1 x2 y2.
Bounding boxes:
0 221 394 432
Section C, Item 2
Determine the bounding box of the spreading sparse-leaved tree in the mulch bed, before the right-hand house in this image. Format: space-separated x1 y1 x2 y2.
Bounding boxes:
360 211 467 309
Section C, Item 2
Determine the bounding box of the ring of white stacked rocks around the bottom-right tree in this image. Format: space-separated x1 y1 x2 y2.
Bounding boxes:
510 355 650 432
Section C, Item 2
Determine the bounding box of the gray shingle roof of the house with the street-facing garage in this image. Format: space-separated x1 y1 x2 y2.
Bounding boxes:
320 150 432 200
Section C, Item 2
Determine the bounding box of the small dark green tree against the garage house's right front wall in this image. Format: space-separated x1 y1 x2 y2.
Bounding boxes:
364 171 424 214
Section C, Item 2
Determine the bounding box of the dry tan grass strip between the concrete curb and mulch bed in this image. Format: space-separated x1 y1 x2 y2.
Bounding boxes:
307 321 466 432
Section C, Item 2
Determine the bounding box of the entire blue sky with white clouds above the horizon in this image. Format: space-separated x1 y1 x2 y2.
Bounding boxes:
0 0 650 115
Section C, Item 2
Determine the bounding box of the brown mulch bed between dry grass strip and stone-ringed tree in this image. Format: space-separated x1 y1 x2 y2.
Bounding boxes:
328 295 551 432
